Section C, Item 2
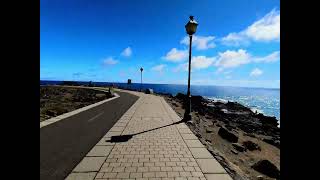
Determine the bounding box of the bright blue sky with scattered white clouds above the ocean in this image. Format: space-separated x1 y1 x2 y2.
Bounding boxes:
40 0 280 88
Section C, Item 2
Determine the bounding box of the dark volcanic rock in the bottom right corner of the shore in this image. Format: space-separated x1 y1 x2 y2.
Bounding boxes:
252 160 280 179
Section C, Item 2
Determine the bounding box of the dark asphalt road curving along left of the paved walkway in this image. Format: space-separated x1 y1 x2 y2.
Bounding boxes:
39 92 138 180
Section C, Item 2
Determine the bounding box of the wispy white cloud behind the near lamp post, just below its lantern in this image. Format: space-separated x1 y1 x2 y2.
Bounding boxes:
180 35 216 50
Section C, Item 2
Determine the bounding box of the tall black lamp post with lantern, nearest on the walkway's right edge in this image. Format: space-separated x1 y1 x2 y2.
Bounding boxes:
183 16 198 121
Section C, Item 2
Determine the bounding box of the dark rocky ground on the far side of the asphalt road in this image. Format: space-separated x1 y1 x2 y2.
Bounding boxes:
40 86 112 122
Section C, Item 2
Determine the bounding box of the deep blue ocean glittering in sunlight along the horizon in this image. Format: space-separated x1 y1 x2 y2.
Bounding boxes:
40 80 280 121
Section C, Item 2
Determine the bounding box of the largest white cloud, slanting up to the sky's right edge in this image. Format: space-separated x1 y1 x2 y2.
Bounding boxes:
221 9 280 46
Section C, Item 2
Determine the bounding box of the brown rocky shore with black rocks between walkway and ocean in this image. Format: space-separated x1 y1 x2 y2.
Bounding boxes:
161 93 280 180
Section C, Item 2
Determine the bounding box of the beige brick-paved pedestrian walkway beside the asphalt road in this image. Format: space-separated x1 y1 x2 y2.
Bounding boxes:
66 91 232 180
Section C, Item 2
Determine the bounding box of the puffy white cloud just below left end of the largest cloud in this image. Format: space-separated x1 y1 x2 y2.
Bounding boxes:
215 49 251 69
